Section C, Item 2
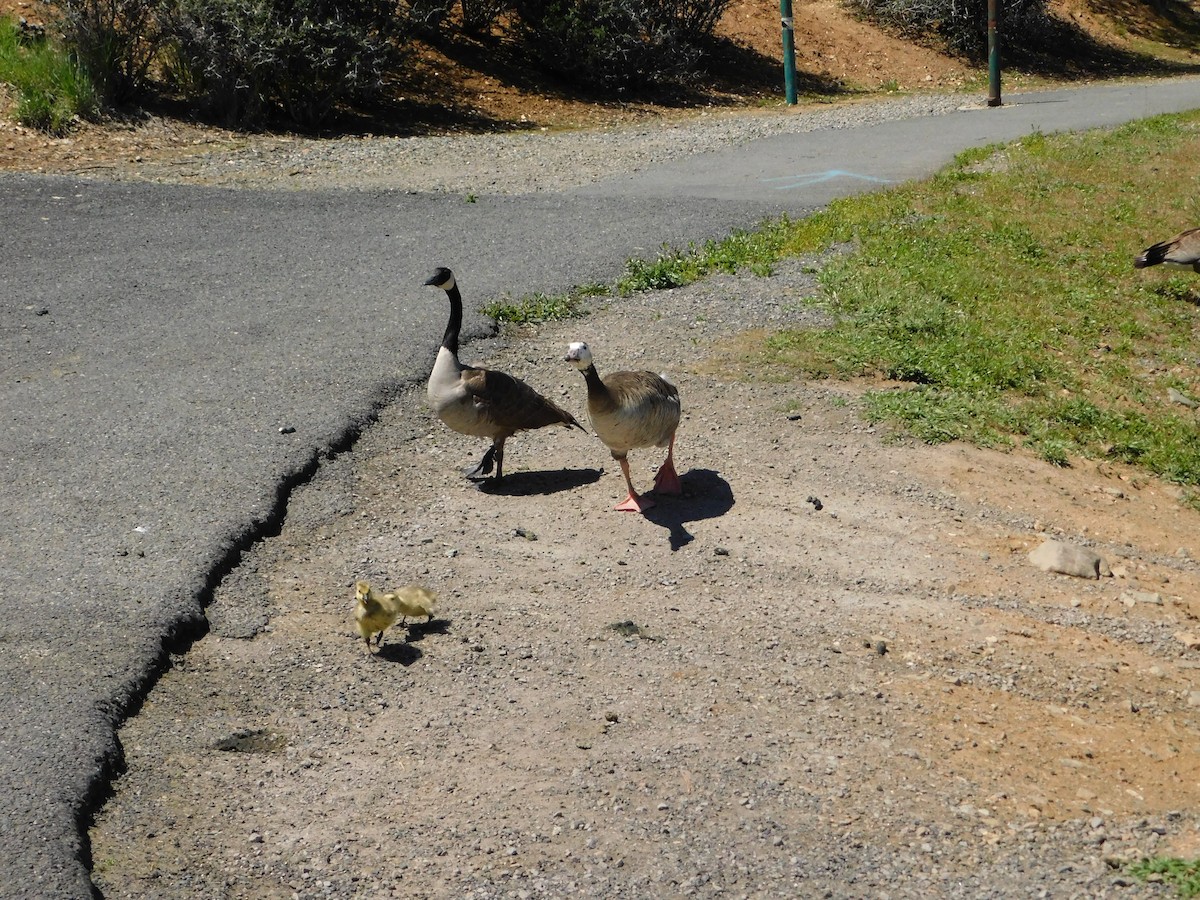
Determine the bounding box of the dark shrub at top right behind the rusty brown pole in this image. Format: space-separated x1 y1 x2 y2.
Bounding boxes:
850 0 1052 60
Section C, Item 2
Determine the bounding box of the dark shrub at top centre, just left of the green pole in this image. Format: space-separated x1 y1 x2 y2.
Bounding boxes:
516 0 728 90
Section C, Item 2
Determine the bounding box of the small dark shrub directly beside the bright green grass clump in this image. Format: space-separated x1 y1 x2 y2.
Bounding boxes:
48 0 158 101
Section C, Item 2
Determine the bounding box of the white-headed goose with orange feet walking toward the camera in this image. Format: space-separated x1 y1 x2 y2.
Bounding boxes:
565 341 682 512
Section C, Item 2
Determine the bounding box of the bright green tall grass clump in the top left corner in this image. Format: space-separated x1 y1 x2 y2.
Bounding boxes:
0 18 100 136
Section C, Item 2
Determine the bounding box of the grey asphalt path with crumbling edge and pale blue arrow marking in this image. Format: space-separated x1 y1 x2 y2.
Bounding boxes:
0 80 1200 898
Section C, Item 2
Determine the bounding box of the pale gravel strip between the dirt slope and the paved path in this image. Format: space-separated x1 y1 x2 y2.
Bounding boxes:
30 92 983 196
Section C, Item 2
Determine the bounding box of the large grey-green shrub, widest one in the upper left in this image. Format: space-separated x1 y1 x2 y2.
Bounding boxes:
162 0 398 127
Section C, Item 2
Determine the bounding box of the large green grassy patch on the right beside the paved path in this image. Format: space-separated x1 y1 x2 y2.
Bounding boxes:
609 113 1200 494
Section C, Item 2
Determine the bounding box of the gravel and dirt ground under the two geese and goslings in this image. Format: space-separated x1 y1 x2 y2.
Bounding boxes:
90 243 1200 898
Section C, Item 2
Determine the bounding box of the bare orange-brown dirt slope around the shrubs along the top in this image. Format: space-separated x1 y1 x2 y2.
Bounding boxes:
0 0 1200 172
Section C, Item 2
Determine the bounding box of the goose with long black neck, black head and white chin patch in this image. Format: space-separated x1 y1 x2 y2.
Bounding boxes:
425 266 587 484
